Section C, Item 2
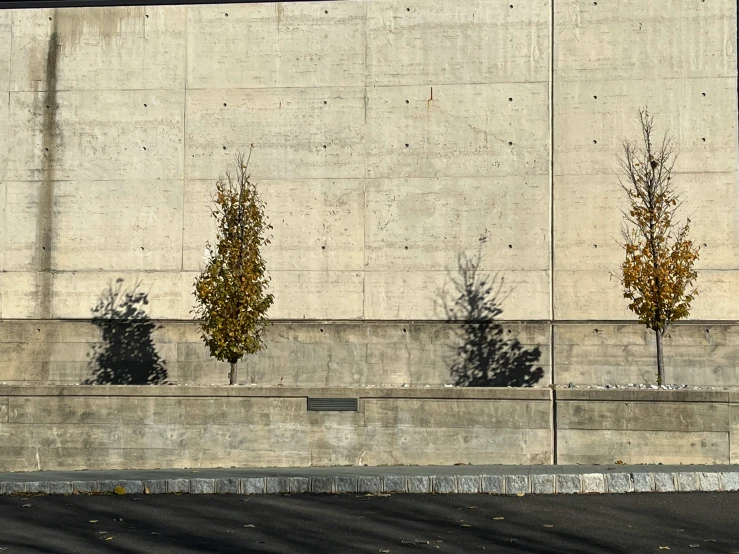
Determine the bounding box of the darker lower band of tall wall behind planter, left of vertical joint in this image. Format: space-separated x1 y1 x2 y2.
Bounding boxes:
0 321 550 386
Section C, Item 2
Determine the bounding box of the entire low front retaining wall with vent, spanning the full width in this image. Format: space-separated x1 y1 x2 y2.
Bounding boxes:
0 386 739 471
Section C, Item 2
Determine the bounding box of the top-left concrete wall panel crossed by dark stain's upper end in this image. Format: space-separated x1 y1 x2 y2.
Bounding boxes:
10 6 185 92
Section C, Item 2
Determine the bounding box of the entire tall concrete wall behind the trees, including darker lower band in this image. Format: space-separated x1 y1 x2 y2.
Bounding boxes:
0 0 739 385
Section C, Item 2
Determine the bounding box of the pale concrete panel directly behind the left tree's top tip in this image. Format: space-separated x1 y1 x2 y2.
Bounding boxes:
185 87 365 180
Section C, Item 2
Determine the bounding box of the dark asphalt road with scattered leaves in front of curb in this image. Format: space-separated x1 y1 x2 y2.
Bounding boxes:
0 493 739 554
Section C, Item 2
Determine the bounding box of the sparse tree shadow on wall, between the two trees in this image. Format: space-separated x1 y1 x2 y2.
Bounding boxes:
443 250 544 387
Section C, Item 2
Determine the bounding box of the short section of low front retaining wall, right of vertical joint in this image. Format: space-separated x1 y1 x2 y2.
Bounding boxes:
556 391 735 464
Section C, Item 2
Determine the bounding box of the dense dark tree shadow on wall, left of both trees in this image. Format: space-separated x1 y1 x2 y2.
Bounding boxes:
84 279 167 385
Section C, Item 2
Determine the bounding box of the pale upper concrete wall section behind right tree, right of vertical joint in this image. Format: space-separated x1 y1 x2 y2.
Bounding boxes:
553 0 739 320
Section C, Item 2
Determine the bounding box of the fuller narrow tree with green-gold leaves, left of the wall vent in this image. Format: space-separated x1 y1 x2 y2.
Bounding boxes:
194 150 273 385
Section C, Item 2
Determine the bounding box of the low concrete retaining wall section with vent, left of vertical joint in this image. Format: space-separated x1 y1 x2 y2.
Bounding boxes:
0 387 552 471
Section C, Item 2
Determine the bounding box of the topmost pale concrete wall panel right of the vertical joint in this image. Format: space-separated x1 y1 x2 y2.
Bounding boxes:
554 0 736 81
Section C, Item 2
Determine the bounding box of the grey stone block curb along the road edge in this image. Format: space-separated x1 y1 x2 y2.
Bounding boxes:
0 472 739 496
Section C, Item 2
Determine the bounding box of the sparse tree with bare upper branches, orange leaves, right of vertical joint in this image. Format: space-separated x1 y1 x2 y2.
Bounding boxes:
619 108 699 385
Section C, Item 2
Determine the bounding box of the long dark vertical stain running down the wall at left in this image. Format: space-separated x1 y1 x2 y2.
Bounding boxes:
35 14 60 319
